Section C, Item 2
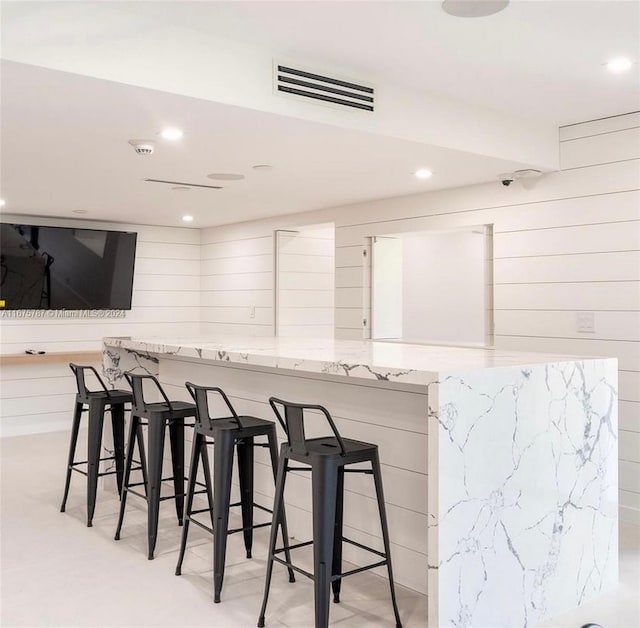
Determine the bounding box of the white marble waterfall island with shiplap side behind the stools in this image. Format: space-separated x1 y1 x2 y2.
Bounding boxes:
104 337 618 628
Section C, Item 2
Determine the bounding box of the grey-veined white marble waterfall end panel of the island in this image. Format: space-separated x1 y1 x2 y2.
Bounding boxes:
429 360 618 628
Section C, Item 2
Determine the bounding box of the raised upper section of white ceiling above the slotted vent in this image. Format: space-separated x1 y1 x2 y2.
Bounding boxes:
115 0 640 126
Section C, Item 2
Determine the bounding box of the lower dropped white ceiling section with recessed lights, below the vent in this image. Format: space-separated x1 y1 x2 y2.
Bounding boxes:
1 61 514 227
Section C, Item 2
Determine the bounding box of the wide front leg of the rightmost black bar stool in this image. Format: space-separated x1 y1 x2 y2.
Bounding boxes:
311 459 338 628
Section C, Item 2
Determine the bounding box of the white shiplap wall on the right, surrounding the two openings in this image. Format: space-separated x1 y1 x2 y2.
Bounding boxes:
203 114 640 522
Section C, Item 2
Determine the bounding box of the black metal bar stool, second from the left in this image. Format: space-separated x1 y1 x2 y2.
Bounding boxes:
115 372 196 560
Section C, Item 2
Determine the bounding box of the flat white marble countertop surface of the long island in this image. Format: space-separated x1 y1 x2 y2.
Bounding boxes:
105 335 589 384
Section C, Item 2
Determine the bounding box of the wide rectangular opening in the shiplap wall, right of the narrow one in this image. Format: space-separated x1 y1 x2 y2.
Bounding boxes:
371 225 493 347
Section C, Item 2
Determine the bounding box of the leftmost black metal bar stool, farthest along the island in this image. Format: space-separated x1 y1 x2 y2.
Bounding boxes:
60 362 144 527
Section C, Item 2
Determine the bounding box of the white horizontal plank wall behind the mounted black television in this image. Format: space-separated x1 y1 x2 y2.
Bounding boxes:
0 221 200 436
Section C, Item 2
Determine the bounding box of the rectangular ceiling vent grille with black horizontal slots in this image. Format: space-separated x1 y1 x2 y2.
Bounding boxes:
275 64 375 111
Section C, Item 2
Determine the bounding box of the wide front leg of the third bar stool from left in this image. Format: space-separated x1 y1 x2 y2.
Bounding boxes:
213 430 235 604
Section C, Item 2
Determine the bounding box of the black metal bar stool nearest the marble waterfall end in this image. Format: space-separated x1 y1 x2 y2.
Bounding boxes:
258 397 402 628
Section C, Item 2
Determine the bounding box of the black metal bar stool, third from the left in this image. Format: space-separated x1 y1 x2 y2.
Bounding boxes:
176 382 295 603
